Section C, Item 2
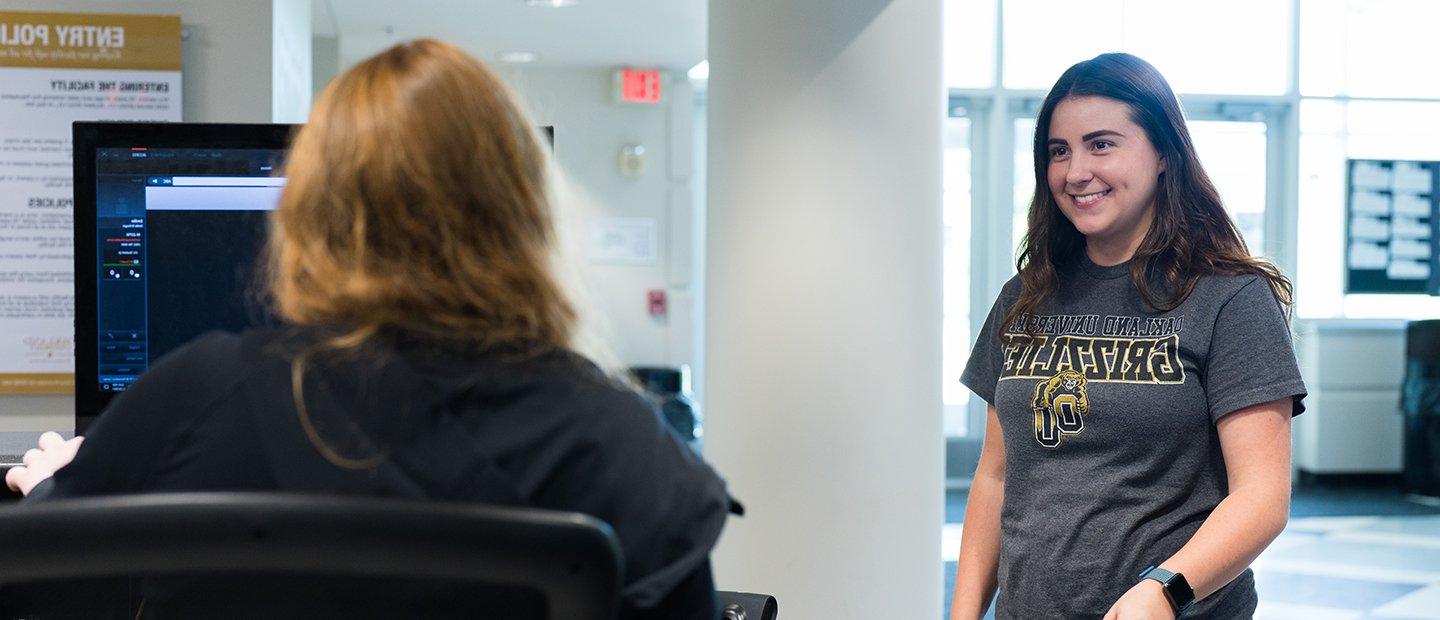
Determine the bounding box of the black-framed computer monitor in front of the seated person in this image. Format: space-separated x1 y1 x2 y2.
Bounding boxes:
73 122 294 434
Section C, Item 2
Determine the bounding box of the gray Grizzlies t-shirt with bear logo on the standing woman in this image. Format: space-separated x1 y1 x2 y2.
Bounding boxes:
960 257 1306 620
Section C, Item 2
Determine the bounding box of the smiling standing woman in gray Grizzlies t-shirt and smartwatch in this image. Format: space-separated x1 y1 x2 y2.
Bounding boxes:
952 53 1306 620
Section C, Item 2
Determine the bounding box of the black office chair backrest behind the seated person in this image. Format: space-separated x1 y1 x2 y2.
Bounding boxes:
0 493 622 620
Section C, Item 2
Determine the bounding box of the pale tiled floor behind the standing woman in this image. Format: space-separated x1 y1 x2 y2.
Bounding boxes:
942 489 1440 620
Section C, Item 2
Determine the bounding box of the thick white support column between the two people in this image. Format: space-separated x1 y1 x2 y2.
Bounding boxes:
706 0 945 619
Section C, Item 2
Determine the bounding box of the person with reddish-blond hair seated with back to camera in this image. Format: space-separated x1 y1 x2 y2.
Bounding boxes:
6 40 730 619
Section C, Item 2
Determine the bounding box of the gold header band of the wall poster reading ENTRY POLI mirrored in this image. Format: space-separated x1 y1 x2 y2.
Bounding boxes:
0 12 180 70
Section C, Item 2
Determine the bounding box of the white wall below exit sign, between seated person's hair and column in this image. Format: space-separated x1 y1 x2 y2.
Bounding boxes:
497 66 700 379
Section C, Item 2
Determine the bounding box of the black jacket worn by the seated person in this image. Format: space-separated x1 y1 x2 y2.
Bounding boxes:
30 329 730 619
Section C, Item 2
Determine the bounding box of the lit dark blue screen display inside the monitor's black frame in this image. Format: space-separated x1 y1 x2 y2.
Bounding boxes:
95 148 285 391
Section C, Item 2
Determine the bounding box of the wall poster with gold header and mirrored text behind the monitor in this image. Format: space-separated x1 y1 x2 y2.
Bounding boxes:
0 12 180 394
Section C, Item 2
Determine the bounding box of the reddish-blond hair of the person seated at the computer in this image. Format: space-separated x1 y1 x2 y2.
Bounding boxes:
266 39 576 468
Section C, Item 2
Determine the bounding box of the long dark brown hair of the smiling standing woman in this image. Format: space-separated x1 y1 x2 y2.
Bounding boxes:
999 53 1293 334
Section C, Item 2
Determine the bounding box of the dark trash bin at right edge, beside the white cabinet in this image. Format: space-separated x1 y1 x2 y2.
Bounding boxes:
1400 321 1440 496
